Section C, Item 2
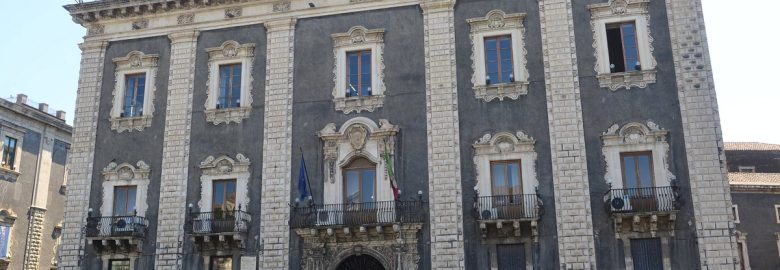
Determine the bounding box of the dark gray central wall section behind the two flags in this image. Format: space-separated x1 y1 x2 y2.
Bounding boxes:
290 6 430 269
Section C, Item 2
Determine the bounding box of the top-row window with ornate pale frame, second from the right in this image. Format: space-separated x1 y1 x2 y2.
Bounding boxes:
468 10 528 101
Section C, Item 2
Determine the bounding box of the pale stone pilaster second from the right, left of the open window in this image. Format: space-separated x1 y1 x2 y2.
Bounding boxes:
539 0 596 269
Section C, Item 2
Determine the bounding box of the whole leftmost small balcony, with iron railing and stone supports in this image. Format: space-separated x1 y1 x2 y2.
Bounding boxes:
85 215 149 253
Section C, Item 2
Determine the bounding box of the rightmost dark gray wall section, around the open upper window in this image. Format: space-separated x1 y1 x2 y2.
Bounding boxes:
572 0 698 269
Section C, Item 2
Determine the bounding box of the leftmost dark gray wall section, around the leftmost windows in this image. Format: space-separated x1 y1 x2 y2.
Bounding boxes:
86 36 171 269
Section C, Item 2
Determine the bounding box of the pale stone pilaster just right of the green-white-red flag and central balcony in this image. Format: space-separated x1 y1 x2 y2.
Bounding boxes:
421 0 464 269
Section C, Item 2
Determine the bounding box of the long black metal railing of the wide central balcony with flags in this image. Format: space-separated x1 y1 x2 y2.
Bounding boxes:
290 200 427 228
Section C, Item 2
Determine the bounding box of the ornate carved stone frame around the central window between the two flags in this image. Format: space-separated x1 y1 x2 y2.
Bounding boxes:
317 117 399 204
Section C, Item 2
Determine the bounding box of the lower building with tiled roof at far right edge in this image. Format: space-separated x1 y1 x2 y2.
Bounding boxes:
726 143 780 269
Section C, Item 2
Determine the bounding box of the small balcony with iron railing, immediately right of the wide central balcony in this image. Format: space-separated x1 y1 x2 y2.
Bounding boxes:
474 194 544 239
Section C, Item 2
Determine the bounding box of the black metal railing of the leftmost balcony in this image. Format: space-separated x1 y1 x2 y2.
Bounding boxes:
85 216 149 237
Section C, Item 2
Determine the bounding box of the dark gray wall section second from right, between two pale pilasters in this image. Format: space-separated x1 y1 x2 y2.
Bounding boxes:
448 0 558 269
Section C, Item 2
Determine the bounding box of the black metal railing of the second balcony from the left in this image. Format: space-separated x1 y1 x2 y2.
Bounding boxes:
190 210 252 234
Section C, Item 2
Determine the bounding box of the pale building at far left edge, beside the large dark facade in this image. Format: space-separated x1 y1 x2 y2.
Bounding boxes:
0 94 72 270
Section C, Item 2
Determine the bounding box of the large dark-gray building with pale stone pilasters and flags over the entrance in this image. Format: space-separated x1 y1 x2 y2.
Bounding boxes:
62 0 739 269
